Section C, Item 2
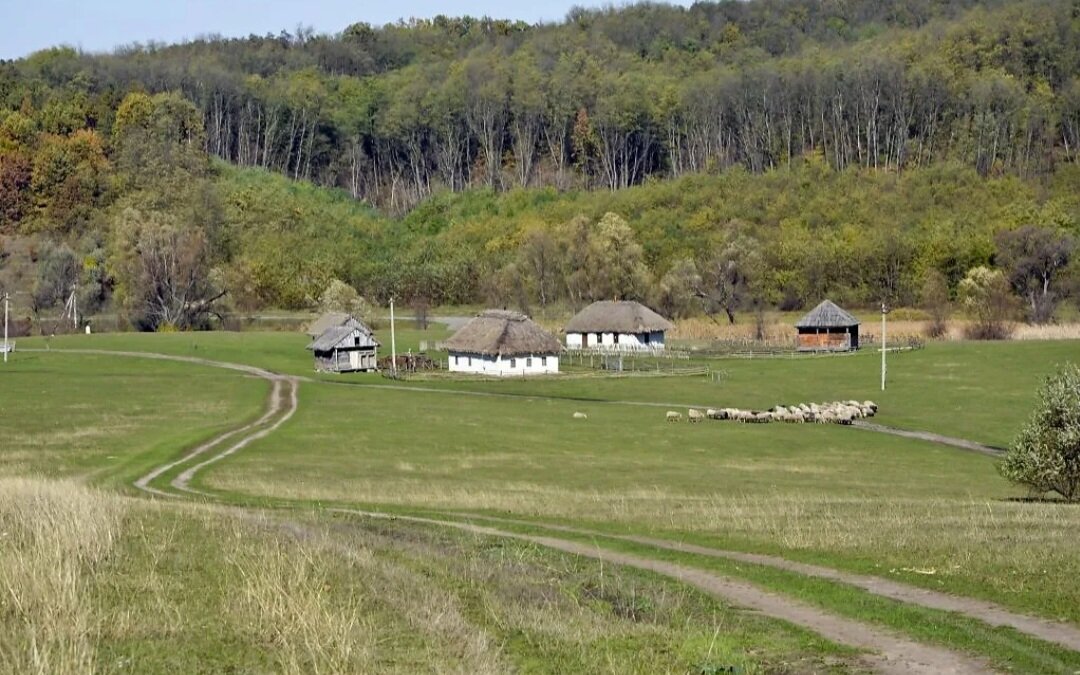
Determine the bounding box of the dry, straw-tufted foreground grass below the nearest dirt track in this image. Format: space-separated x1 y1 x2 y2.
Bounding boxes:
0 478 861 674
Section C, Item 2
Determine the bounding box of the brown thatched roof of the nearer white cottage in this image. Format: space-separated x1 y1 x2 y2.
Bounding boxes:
446 309 563 356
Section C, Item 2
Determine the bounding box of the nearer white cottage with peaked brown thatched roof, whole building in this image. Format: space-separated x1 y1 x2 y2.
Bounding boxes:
445 309 563 376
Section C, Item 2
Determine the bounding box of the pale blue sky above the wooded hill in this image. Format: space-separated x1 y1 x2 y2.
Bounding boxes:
0 0 690 58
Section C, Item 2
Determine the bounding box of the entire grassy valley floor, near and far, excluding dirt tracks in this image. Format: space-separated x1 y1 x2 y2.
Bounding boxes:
0 328 1080 673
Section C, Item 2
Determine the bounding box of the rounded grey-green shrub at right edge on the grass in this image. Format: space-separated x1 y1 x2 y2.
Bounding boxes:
998 364 1080 501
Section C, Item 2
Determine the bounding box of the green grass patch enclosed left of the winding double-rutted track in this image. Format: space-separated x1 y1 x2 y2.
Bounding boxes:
0 352 267 485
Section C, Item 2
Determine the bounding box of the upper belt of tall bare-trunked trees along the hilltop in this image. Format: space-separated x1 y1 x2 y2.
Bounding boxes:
0 0 1080 213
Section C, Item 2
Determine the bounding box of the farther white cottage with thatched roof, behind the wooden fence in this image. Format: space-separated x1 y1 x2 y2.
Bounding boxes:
566 300 673 351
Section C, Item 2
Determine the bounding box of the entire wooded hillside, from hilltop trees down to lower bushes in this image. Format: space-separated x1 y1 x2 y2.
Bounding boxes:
0 0 1080 328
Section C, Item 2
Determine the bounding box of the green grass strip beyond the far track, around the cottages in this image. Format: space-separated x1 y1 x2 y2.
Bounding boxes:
22 326 1080 447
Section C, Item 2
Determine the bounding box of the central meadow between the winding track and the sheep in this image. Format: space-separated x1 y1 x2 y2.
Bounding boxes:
195 386 1080 622
